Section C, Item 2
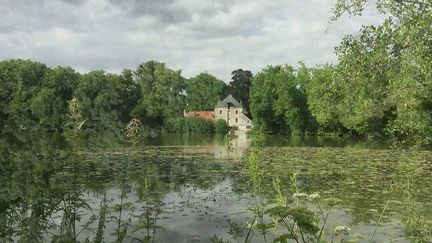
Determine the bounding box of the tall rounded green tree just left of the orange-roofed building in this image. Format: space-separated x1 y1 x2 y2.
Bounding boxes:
131 61 185 124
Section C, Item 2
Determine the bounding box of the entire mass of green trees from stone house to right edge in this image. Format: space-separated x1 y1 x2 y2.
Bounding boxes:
246 0 432 145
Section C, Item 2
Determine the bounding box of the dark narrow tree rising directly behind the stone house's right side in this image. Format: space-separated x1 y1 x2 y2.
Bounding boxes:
228 69 253 114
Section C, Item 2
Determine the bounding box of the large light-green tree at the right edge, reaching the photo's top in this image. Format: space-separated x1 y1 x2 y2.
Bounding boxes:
332 0 432 144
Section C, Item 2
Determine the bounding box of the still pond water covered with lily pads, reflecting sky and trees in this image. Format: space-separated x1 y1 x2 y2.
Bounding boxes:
0 135 432 242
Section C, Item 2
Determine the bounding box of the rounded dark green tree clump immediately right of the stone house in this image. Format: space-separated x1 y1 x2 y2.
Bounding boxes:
250 65 316 134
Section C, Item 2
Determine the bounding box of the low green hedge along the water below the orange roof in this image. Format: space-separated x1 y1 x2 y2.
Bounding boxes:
164 117 215 133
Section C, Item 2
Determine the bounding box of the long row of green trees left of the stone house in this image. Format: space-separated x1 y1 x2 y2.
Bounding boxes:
0 59 253 139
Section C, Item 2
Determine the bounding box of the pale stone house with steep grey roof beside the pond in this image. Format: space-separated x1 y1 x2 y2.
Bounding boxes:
214 95 252 131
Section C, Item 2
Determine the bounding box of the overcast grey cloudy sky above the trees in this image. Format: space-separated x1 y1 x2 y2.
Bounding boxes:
0 0 381 81
